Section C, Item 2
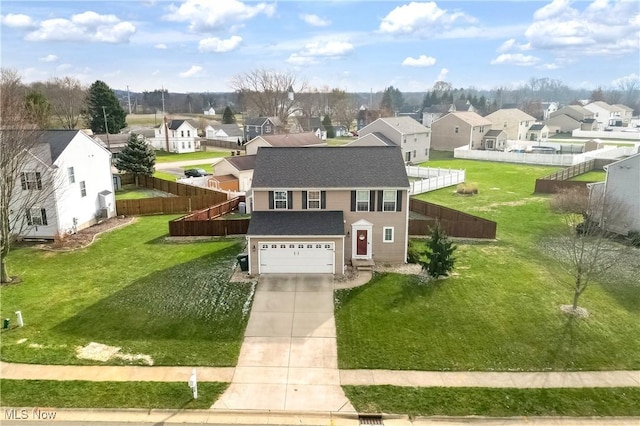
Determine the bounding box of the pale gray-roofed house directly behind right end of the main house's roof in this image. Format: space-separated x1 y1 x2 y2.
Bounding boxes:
349 116 431 163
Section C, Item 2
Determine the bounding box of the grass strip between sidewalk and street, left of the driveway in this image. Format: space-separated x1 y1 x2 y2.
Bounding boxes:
0 379 228 415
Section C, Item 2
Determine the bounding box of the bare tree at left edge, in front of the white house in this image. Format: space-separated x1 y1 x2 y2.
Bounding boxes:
0 68 59 283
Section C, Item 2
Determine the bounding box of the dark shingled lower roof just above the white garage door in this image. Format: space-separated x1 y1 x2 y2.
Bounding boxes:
247 210 344 236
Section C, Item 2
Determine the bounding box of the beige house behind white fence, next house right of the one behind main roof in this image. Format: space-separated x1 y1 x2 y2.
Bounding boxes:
431 111 498 151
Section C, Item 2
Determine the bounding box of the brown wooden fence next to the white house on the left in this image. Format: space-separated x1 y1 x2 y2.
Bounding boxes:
116 174 227 216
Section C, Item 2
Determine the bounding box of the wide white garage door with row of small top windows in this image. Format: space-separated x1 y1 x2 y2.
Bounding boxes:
259 242 335 274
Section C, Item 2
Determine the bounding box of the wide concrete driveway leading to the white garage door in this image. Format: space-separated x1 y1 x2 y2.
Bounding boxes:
212 274 355 412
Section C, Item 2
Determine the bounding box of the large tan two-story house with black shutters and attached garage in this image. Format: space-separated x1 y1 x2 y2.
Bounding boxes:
247 146 409 275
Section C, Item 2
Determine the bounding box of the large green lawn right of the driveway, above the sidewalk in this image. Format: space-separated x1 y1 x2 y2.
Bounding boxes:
336 158 640 371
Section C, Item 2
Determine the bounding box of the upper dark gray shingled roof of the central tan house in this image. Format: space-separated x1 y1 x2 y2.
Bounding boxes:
252 146 409 189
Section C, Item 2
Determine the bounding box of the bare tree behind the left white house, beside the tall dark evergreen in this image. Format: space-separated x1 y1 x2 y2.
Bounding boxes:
42 77 87 129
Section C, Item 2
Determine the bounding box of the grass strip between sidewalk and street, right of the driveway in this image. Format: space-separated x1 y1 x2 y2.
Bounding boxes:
343 386 640 417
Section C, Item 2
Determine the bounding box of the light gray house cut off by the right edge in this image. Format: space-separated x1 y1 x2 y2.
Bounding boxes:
587 152 640 235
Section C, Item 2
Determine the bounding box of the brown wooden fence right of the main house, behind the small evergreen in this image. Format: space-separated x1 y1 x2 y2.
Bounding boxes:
409 198 497 239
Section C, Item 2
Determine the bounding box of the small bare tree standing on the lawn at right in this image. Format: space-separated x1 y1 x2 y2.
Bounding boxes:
551 187 627 313
